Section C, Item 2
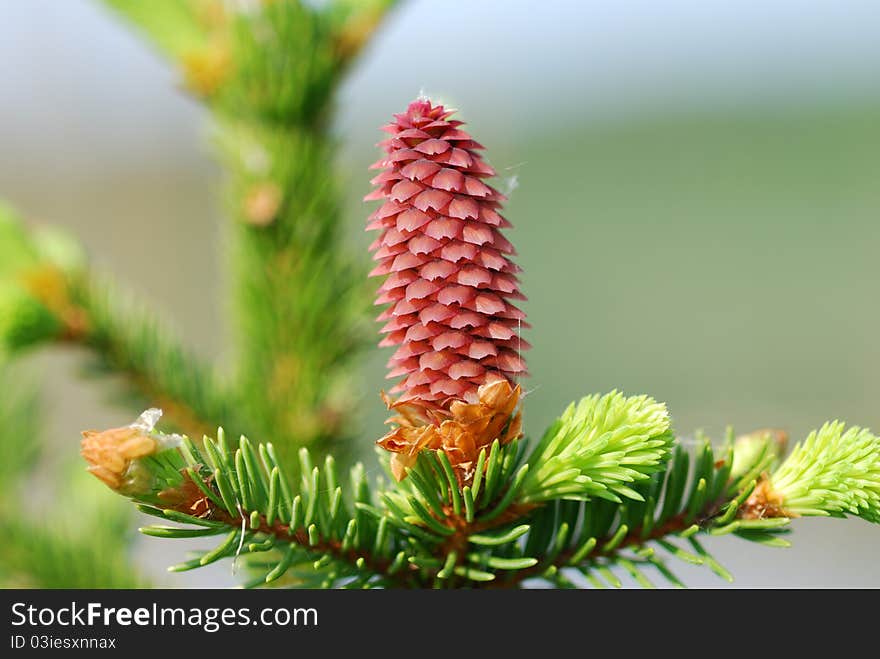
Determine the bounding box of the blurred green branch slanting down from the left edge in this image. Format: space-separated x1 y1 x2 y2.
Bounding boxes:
0 201 245 437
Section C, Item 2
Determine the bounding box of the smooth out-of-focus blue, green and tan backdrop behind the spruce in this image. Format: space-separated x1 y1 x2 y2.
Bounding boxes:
0 0 880 587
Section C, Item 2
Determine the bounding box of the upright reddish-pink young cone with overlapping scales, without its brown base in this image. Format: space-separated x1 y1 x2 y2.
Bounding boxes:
365 99 528 407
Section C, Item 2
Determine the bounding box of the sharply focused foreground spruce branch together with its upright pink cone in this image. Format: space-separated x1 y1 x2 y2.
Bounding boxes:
83 99 880 588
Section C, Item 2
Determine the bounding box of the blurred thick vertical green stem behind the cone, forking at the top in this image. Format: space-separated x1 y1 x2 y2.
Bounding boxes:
97 0 396 461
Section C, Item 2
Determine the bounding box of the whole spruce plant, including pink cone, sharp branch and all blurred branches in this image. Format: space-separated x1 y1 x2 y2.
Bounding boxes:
0 0 880 588
